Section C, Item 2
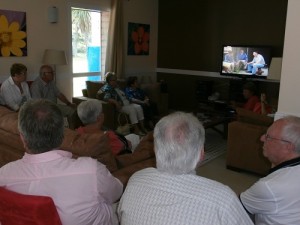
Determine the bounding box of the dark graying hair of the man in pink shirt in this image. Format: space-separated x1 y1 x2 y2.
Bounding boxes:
18 99 64 154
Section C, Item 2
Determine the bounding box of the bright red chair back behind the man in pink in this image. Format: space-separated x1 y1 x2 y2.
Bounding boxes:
0 187 62 225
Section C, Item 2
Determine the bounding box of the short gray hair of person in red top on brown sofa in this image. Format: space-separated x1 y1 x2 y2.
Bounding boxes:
77 99 102 125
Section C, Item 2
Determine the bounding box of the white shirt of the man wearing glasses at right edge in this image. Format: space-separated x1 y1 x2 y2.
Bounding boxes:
240 165 300 225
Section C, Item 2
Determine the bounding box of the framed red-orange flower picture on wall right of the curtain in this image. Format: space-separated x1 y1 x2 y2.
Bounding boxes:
127 23 150 55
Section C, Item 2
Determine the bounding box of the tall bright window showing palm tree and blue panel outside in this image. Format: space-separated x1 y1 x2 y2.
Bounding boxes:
71 7 109 96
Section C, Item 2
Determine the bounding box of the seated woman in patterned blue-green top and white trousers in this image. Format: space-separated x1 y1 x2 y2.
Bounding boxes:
98 72 147 135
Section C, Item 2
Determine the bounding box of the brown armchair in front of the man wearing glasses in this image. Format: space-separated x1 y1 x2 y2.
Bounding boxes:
226 108 273 175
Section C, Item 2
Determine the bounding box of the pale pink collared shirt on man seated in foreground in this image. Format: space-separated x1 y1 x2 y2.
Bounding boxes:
0 150 123 225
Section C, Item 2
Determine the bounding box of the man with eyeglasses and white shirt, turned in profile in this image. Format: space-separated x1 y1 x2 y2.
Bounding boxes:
240 116 300 225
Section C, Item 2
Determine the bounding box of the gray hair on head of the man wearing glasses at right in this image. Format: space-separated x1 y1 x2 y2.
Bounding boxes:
281 116 300 154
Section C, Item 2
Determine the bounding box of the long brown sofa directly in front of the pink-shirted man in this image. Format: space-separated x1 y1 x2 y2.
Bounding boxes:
0 106 156 186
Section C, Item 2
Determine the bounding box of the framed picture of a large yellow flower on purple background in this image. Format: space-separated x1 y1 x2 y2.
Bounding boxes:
0 9 27 57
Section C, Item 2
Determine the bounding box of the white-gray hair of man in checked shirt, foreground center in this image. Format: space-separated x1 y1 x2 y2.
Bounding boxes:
154 112 205 174
